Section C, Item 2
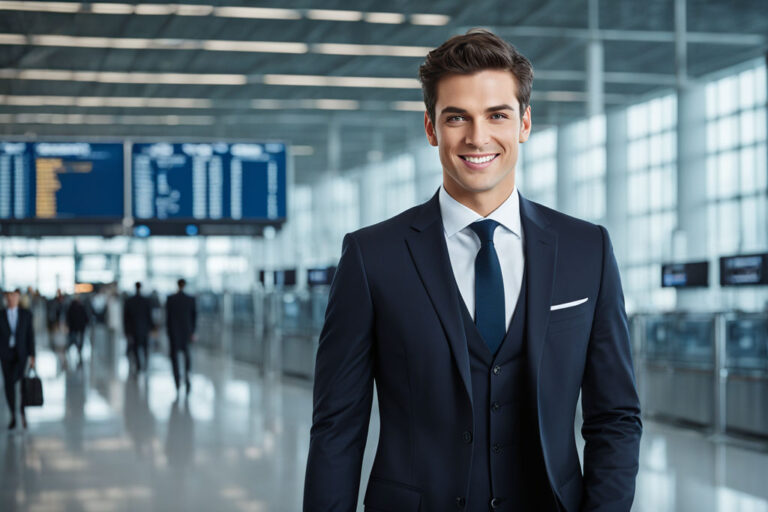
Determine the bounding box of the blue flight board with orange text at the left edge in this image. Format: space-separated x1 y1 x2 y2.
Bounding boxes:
0 142 124 221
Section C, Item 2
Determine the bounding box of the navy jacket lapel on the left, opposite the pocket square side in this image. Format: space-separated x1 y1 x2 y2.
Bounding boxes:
406 194 472 402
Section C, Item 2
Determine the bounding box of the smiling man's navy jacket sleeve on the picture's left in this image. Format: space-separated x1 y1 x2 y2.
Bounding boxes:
304 234 374 512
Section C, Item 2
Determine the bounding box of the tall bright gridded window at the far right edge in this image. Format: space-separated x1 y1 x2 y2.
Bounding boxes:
705 63 766 255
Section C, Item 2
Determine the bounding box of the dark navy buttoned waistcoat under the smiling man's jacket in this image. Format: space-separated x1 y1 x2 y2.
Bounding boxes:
462 269 558 512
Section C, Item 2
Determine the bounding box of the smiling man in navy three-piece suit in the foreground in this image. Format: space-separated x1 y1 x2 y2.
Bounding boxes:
304 30 642 512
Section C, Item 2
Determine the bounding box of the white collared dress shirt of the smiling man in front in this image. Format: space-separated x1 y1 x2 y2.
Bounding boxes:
439 187 525 327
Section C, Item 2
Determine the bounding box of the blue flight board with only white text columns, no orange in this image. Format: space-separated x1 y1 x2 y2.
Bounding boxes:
131 142 286 224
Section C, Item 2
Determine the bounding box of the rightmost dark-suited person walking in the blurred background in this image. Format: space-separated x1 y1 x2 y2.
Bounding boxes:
165 279 197 393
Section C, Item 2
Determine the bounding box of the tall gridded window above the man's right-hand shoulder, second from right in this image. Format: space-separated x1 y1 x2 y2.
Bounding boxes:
623 95 677 309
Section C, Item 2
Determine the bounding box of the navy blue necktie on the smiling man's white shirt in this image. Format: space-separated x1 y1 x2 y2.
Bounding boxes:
469 219 507 354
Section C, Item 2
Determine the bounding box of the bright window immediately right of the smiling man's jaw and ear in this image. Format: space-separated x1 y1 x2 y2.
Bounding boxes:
515 128 557 208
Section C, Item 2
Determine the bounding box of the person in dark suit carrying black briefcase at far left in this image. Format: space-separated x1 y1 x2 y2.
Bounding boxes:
0 290 35 430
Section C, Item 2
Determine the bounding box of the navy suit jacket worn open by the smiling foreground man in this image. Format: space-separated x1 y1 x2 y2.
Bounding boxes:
304 194 642 512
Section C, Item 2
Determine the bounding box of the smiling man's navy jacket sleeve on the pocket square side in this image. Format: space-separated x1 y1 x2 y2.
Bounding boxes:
581 226 642 512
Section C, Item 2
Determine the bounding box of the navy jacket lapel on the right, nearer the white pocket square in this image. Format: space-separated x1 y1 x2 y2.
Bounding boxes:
520 196 557 404
